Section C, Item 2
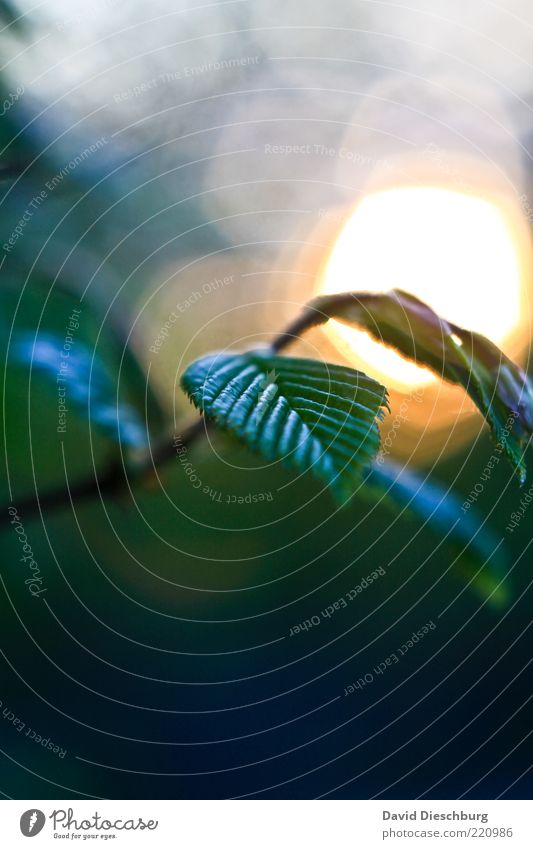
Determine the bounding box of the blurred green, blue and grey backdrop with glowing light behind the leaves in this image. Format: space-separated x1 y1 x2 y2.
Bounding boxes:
0 0 533 799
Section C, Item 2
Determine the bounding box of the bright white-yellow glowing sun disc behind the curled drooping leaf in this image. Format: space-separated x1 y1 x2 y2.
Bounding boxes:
320 187 529 392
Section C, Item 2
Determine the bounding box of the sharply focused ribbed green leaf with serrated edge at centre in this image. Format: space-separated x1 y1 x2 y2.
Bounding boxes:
181 351 387 501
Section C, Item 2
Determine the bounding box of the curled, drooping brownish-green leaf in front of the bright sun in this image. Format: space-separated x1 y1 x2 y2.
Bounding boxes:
308 289 533 483
